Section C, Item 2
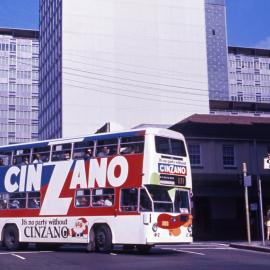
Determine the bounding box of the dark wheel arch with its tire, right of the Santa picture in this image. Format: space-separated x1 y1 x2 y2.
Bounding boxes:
89 223 113 253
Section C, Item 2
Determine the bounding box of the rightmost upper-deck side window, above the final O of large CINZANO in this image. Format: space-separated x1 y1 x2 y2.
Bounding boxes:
120 136 144 155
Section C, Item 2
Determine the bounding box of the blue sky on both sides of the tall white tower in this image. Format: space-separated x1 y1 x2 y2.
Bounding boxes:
0 0 270 49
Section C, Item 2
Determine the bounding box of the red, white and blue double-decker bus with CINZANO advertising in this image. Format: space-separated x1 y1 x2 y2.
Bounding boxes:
0 128 192 252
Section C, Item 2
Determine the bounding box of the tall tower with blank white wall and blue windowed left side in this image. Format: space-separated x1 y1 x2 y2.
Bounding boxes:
39 0 209 139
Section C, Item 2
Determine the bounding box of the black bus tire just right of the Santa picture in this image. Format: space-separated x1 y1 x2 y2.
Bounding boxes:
95 225 112 253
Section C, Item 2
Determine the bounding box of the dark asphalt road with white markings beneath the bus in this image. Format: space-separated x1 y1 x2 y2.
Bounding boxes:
0 242 270 270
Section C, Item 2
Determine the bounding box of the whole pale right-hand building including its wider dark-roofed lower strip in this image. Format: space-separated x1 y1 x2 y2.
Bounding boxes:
210 46 270 117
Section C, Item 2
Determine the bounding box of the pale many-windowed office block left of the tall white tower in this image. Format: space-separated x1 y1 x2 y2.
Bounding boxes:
0 28 39 145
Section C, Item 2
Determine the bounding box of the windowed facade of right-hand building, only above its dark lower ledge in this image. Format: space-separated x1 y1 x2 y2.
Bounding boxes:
229 47 270 103
